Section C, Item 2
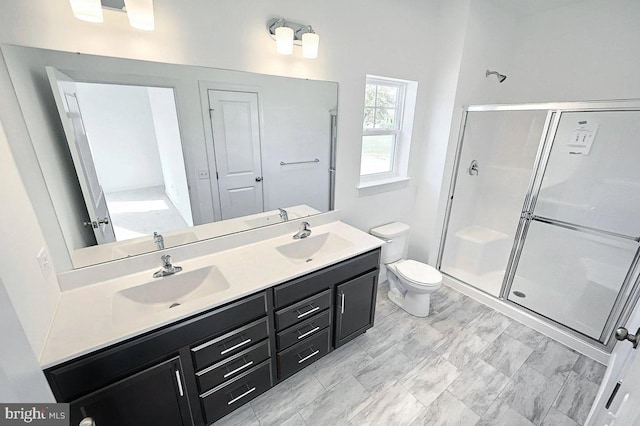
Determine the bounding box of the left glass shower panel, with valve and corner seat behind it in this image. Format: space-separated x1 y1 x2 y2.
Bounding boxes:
438 110 548 297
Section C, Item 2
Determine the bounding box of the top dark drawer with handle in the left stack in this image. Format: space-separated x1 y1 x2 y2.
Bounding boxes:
191 317 269 371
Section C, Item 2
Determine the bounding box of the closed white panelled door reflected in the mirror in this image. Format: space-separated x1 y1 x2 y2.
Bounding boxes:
208 90 264 219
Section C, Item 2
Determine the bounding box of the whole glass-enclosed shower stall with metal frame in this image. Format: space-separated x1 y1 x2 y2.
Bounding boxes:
437 101 640 350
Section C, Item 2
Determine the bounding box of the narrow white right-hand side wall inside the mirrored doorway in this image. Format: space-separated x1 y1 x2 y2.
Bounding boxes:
147 87 193 226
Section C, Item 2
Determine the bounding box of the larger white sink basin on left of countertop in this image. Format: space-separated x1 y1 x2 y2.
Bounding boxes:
112 266 229 321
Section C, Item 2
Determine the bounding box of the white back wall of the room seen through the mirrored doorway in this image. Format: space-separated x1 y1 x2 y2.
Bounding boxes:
76 83 164 193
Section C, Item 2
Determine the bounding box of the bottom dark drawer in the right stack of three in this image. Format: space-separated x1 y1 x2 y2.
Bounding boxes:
278 328 331 379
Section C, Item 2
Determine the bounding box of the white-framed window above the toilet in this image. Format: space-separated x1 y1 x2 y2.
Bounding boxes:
360 76 417 186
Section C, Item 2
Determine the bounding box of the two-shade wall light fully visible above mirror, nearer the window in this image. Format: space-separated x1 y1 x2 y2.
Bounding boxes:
267 18 320 59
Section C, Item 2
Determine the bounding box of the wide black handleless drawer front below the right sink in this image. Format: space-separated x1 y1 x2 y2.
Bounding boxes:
273 249 380 309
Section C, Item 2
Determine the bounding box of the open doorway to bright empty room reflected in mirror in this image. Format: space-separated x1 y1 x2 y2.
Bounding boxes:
47 67 193 244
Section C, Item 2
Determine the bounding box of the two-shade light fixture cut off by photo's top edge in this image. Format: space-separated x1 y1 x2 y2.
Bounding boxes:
69 0 155 31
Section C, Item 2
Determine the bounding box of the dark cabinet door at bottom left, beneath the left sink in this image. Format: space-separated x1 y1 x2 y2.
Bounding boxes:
70 357 192 426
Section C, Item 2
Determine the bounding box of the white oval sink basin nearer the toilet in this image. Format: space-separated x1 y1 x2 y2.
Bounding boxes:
276 232 353 264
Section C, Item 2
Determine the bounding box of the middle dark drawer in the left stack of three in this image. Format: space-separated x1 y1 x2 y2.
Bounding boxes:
196 340 271 392
